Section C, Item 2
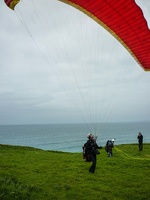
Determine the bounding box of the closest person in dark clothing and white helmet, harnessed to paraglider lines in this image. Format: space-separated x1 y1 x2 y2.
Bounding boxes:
83 134 102 173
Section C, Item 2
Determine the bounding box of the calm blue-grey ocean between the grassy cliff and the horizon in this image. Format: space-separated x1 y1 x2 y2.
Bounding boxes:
0 122 150 152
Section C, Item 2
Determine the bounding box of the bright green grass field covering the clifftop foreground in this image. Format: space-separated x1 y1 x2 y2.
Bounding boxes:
0 144 150 200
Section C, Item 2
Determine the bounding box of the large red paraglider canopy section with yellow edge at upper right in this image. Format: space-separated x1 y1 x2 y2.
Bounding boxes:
59 0 150 71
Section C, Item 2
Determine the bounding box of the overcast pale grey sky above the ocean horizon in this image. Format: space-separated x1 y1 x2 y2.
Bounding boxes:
0 0 150 125
